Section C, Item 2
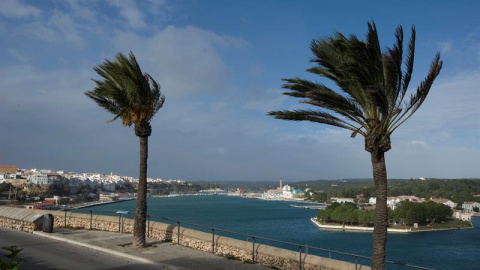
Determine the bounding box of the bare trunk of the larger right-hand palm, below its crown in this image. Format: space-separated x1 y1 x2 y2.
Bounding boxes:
371 150 388 270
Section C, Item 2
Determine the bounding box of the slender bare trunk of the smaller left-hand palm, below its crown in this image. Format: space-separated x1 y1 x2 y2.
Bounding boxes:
133 136 148 247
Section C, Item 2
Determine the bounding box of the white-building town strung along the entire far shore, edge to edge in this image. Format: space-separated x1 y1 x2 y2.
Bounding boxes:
0 165 480 221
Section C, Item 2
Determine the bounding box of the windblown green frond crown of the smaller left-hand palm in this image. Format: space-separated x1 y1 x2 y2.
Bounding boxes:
85 52 165 135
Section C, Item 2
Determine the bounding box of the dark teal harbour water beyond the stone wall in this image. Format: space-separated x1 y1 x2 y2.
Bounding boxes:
80 196 480 270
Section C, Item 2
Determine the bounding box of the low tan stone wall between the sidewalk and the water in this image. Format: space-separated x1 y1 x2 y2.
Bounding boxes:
0 207 370 270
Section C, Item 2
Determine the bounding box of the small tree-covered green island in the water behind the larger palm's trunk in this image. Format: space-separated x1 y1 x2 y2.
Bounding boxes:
312 201 473 232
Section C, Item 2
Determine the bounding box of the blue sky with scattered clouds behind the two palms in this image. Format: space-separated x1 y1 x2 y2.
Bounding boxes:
0 0 480 181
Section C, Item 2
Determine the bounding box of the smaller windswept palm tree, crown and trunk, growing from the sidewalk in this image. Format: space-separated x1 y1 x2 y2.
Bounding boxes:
85 52 165 247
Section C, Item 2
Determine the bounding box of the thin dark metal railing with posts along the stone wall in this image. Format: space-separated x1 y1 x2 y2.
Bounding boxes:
63 209 434 270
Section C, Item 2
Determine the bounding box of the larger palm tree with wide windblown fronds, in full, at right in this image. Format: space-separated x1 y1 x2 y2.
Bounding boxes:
268 22 443 269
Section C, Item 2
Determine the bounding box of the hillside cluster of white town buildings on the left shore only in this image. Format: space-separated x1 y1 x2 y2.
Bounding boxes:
0 165 191 209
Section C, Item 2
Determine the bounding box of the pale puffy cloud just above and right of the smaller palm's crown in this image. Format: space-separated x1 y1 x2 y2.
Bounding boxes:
113 26 248 99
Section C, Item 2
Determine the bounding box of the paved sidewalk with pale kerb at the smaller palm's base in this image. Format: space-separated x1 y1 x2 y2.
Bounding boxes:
34 228 269 270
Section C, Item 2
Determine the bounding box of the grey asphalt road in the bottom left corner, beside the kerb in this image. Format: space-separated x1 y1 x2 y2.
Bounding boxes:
0 228 172 270
